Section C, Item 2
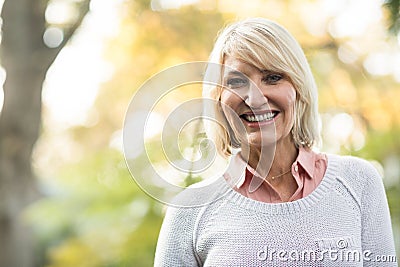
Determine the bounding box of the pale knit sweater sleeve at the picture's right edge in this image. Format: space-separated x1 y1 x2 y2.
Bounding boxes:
361 163 397 266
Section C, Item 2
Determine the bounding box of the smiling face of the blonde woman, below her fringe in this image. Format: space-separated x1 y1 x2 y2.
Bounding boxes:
221 56 296 149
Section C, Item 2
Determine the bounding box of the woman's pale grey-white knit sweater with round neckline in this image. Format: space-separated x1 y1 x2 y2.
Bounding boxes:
155 155 397 267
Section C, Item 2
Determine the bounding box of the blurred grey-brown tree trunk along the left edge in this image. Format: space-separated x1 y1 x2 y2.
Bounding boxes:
0 0 49 267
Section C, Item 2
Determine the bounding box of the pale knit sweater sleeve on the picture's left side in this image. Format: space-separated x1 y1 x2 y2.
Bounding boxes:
154 207 200 267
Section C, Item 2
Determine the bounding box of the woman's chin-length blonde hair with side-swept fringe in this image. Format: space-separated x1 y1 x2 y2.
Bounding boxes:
203 18 320 156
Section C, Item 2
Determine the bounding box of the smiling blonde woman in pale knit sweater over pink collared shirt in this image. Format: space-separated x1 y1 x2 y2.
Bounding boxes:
155 18 397 266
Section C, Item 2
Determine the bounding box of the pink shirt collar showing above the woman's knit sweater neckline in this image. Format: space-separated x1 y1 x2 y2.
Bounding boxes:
224 147 328 203
